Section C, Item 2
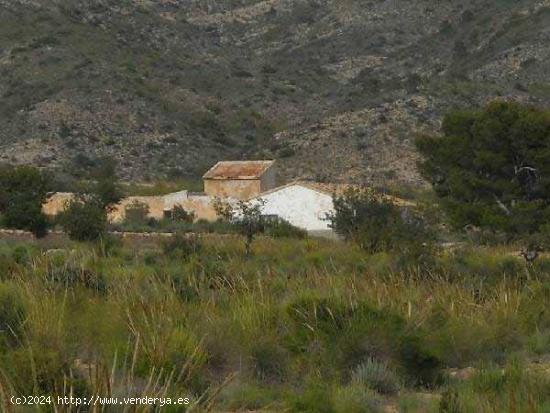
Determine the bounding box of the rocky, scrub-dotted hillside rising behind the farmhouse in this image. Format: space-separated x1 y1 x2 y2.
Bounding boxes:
0 0 550 183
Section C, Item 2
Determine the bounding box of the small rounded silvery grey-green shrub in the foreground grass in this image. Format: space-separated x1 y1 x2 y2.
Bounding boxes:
352 358 400 394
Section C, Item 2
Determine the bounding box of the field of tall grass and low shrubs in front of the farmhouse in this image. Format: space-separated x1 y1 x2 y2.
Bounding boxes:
0 236 550 413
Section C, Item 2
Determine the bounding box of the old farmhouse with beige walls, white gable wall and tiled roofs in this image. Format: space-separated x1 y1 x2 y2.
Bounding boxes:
43 160 410 233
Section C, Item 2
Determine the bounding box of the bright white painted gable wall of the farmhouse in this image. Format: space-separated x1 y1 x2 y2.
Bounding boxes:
253 184 334 231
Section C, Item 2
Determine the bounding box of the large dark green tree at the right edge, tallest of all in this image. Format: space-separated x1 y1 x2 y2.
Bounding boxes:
416 101 550 237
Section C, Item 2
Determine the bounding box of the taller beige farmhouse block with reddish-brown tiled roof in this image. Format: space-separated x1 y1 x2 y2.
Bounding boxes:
203 161 276 200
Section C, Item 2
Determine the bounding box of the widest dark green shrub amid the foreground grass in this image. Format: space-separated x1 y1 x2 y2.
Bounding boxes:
286 296 441 389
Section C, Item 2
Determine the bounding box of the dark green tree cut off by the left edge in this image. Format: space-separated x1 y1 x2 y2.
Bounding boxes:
0 166 51 238
